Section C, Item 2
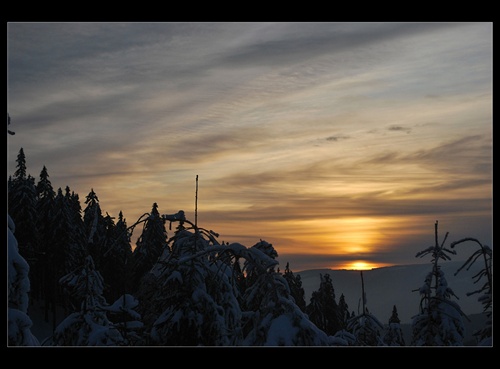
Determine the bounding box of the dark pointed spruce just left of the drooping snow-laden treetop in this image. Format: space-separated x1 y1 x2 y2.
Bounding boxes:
130 202 168 293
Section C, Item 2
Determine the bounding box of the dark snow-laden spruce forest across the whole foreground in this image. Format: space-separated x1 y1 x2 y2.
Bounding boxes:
7 142 492 347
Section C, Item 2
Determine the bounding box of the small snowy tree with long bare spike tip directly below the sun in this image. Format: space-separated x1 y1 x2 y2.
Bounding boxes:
347 270 384 346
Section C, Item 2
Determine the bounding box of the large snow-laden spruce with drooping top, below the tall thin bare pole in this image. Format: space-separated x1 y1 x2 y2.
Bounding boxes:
137 211 241 346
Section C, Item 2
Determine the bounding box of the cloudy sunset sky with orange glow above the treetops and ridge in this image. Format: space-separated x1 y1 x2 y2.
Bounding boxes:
7 22 493 271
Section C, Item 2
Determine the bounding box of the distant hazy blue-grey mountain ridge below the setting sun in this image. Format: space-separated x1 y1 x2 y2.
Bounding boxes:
294 260 484 324
